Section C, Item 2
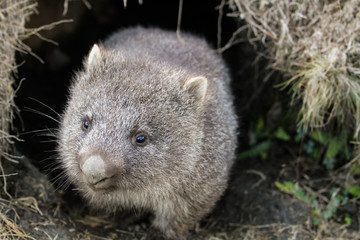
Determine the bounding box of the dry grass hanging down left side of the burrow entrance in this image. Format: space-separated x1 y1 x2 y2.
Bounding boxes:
0 0 36 178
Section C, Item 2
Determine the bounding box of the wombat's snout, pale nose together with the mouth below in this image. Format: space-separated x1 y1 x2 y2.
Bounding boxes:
79 154 116 189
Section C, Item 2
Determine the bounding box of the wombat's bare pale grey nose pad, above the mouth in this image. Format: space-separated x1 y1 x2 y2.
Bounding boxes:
80 155 113 185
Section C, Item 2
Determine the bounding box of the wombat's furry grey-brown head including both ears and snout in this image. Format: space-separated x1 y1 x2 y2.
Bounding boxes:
59 45 208 197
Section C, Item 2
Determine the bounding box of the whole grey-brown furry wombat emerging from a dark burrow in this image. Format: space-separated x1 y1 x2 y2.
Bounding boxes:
58 27 237 239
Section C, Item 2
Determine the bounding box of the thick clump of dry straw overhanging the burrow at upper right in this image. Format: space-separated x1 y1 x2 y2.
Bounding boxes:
223 0 360 138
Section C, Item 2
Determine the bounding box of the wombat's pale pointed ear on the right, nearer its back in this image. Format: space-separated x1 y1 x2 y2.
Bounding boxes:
182 76 208 102
